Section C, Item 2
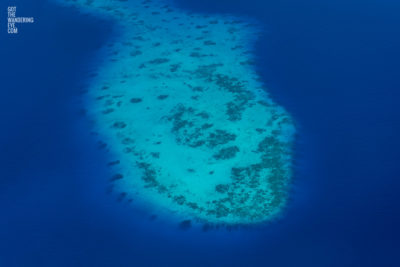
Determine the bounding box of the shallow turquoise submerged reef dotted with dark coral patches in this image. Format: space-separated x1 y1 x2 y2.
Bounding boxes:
54 0 295 225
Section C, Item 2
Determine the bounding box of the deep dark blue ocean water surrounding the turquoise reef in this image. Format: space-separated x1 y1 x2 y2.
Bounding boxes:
0 0 400 267
